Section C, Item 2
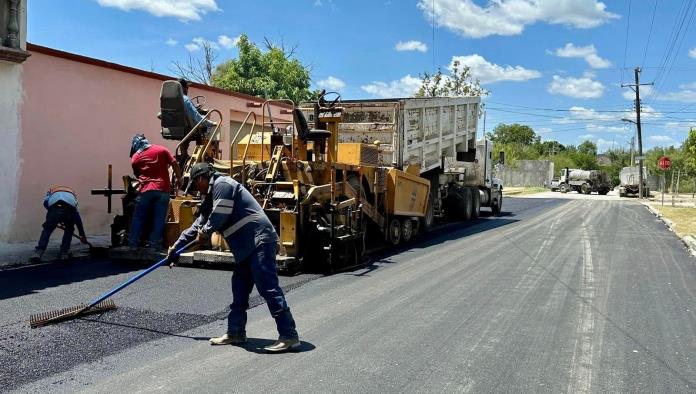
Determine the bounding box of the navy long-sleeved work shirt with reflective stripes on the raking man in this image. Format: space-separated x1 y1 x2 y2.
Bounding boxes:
174 175 278 262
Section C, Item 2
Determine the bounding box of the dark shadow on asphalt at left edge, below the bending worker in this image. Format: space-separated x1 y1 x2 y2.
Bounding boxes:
0 260 139 300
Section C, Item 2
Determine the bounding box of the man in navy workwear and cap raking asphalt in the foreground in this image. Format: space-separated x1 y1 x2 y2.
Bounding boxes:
167 163 300 352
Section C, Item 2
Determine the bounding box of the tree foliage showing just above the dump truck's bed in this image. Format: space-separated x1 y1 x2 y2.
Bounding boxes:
415 61 489 97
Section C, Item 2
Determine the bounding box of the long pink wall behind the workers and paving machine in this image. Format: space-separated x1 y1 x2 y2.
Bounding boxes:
16 49 288 241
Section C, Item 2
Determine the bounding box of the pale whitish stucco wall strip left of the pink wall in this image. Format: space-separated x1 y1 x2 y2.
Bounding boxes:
0 62 22 242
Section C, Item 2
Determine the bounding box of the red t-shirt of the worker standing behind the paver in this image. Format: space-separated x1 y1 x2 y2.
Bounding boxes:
131 145 175 193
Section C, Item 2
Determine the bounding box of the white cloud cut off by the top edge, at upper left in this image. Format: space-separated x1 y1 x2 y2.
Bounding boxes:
97 0 220 21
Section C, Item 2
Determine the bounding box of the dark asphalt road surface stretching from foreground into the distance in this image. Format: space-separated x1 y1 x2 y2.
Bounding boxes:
0 196 696 393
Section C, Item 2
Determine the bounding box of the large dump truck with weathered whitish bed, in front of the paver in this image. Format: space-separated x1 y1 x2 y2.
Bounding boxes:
338 97 504 223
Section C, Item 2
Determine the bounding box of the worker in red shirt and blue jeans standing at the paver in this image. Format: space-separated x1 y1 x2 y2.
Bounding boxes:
128 134 181 249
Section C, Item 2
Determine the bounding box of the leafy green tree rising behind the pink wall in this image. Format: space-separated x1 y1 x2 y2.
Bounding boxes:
211 34 316 103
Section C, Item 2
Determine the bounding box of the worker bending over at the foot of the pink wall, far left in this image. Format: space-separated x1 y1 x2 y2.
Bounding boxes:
31 186 87 261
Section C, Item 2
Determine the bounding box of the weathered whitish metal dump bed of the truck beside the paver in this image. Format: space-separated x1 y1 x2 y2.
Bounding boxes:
339 97 481 173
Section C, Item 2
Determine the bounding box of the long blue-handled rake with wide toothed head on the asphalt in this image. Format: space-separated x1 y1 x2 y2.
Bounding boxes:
29 240 196 328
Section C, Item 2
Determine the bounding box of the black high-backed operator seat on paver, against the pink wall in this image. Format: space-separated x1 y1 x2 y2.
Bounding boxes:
158 81 196 141
